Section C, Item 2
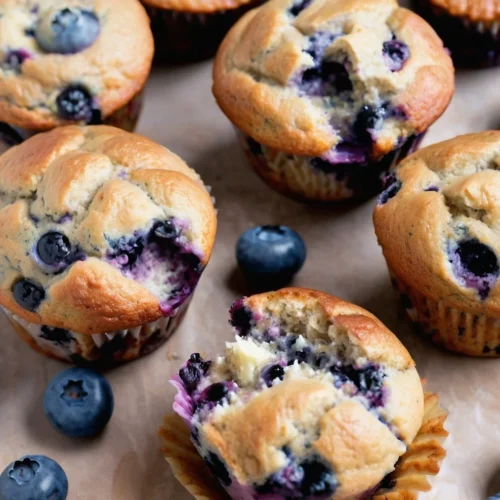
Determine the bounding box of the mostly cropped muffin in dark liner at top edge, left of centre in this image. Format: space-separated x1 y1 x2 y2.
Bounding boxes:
142 0 264 63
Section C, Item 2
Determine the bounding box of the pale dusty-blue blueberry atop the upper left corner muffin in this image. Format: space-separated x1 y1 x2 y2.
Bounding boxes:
35 7 100 54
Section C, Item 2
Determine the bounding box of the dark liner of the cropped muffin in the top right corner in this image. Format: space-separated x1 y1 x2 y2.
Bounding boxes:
419 0 500 68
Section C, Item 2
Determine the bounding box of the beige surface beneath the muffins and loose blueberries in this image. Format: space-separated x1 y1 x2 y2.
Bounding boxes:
0 18 500 500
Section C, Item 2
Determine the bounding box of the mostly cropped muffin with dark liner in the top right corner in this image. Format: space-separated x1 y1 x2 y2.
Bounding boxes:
419 0 500 68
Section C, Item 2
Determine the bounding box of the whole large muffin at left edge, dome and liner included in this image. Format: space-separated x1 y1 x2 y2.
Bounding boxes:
0 125 216 363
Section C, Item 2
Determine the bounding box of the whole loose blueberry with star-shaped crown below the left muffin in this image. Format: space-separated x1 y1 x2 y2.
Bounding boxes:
43 368 114 437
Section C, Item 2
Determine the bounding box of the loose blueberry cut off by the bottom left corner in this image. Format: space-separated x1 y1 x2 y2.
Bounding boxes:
0 455 68 500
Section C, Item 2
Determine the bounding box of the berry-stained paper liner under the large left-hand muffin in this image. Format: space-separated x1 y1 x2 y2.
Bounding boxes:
2 299 190 365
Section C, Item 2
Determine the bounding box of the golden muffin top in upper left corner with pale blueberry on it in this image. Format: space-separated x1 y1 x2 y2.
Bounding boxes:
0 0 154 130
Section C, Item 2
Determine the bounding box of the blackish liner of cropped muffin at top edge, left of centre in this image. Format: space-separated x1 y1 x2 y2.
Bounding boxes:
145 0 263 63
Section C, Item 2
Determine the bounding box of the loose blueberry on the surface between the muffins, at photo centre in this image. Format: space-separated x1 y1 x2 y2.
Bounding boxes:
236 226 306 289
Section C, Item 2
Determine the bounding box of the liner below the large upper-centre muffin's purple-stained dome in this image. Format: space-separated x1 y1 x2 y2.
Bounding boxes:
237 131 424 202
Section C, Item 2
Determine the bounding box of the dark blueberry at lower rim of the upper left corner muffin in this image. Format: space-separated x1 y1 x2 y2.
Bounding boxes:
56 84 101 125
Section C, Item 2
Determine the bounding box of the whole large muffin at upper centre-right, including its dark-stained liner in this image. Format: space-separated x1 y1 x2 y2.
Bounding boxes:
213 0 454 201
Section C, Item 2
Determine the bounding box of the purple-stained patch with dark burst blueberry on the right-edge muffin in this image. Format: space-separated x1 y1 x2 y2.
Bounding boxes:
448 238 500 300
